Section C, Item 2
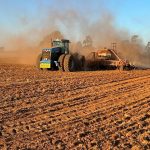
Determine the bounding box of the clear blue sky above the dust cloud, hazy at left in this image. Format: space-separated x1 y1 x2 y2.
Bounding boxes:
0 0 150 46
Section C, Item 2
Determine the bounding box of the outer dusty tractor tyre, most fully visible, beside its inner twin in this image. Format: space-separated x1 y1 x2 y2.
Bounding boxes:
64 55 75 72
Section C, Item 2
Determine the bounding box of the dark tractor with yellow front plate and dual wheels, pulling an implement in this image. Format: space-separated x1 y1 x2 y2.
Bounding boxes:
37 39 84 72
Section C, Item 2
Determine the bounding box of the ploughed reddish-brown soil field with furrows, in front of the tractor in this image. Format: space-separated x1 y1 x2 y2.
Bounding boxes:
0 64 150 150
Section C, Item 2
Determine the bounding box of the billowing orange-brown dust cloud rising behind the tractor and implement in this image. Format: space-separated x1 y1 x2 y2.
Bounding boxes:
0 6 150 67
